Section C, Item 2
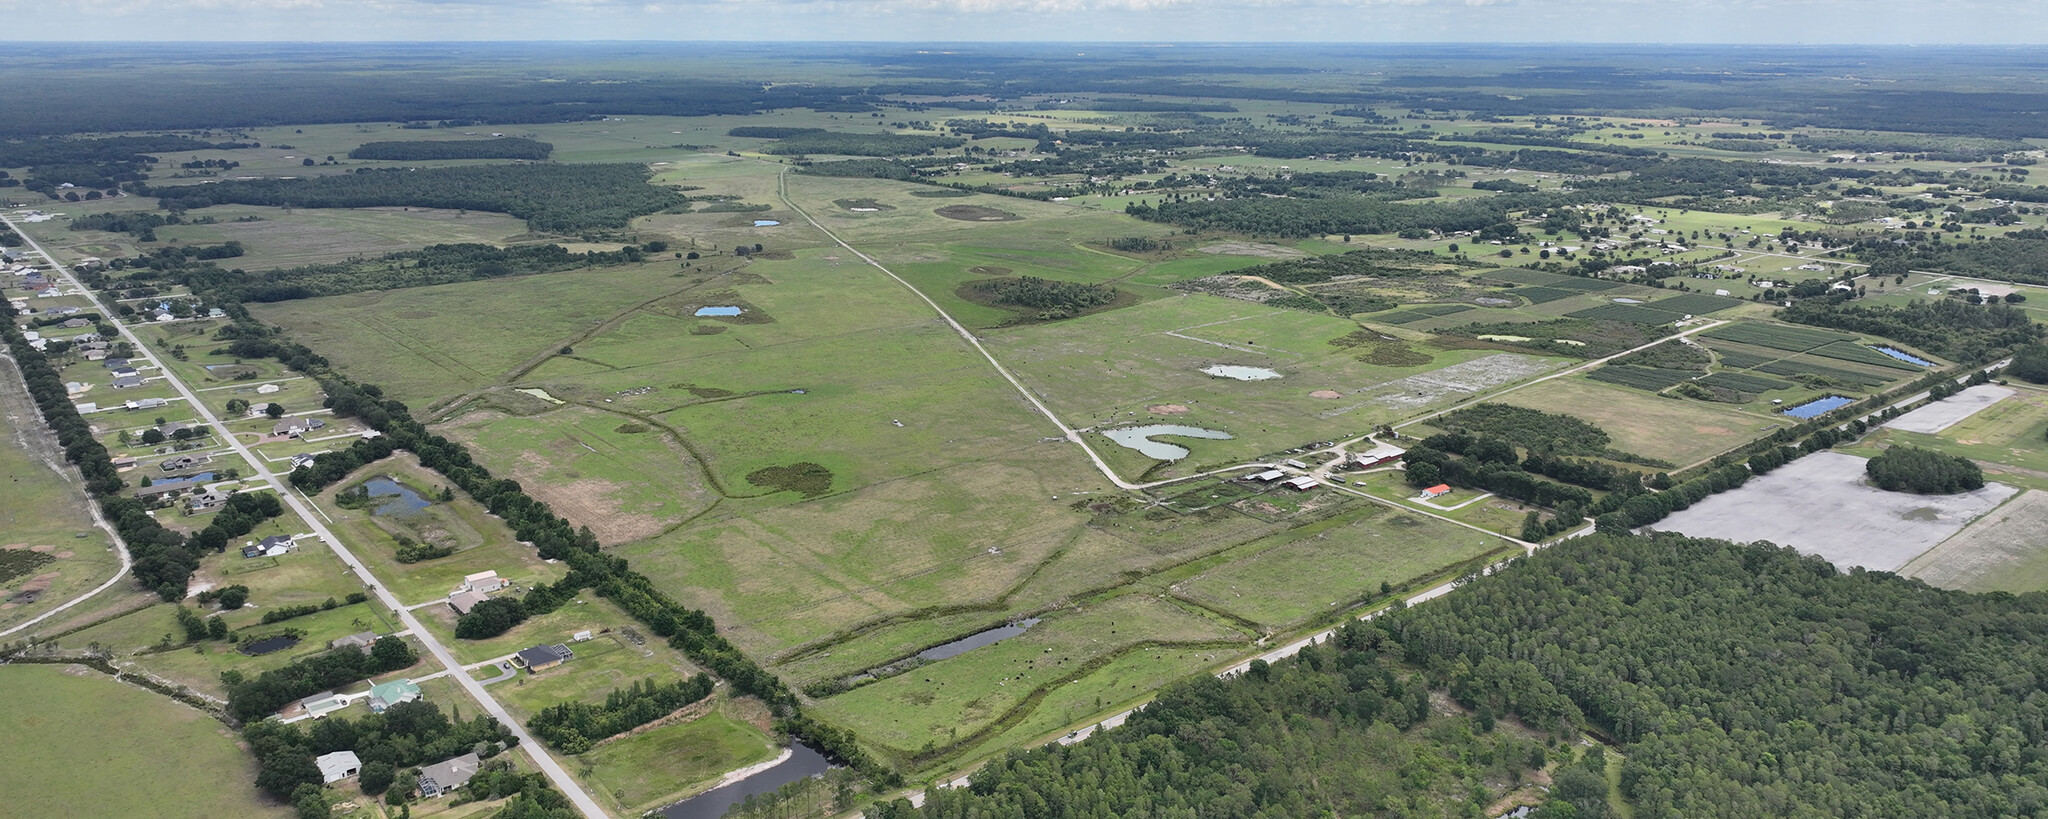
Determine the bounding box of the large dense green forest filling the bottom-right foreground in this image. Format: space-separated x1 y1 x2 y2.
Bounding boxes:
892 534 2048 819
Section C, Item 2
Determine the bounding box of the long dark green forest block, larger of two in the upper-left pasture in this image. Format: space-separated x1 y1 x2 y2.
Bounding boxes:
139 164 688 233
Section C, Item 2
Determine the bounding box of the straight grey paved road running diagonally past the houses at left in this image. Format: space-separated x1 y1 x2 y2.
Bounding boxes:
0 215 608 819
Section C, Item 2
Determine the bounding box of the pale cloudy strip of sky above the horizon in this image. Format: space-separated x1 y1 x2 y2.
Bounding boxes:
12 0 2048 45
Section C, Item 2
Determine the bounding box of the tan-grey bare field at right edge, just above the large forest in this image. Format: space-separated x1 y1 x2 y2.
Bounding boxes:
1898 491 2048 594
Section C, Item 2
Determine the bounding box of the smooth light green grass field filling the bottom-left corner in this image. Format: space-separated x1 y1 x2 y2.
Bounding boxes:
0 665 291 819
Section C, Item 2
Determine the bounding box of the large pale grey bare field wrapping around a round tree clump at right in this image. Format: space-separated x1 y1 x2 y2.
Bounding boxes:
1651 452 2019 571
